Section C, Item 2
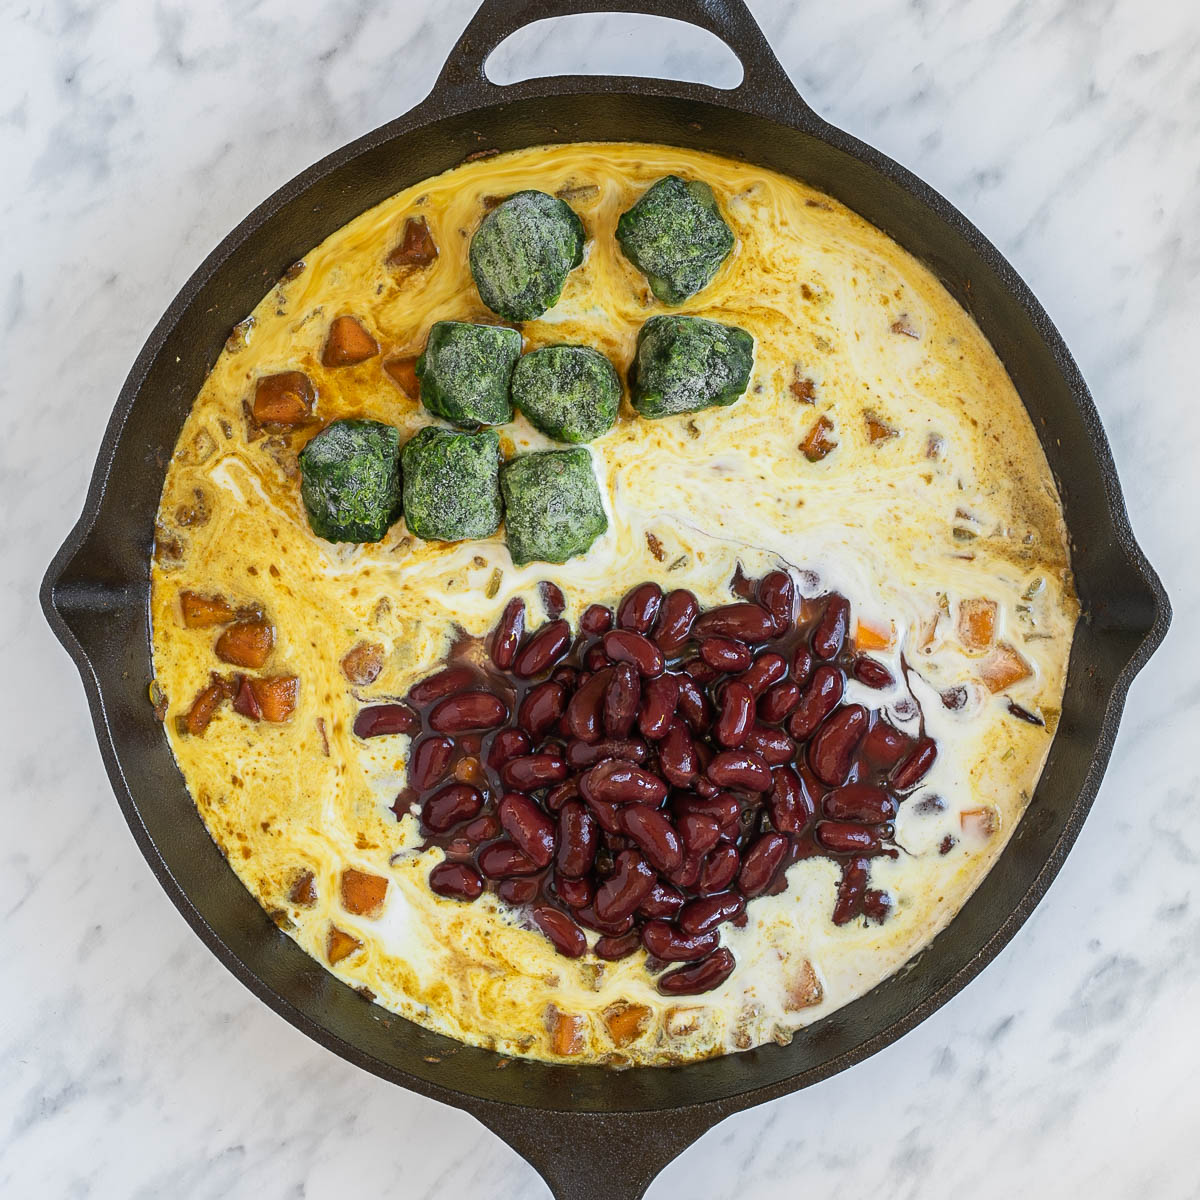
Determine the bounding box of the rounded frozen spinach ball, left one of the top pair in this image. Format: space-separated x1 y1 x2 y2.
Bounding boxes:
470 191 583 322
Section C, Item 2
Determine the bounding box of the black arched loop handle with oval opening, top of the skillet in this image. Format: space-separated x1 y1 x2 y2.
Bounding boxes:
433 0 824 127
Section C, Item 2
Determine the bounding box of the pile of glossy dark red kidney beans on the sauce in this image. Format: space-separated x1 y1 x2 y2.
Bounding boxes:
354 571 937 995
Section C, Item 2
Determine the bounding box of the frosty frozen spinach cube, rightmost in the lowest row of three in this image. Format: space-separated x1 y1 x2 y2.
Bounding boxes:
500 449 608 566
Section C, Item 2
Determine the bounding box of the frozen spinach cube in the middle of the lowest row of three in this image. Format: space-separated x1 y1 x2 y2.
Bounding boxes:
400 425 502 541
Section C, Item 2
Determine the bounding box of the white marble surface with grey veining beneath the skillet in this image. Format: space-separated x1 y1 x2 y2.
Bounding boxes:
0 0 1200 1200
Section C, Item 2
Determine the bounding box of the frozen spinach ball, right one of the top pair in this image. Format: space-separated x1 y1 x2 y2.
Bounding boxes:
617 175 733 304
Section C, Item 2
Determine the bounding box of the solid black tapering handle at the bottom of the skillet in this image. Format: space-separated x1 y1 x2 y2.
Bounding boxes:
464 1103 725 1200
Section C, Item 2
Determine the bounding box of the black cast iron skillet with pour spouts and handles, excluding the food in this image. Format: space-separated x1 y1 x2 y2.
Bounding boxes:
42 0 1170 1200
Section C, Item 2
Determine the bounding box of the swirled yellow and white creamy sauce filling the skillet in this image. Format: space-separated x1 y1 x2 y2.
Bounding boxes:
152 144 1078 1063
